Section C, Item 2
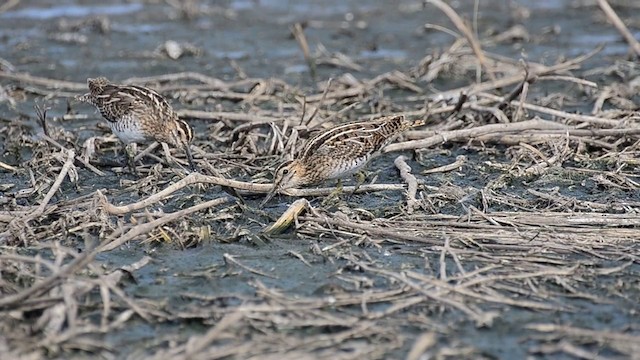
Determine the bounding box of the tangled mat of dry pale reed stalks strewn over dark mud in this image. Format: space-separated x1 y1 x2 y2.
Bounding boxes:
0 1 640 359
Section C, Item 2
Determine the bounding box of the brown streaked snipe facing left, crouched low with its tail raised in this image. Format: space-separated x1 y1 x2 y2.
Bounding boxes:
262 115 425 206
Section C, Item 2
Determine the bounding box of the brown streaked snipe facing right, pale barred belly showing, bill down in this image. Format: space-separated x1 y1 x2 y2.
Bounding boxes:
76 77 196 172
